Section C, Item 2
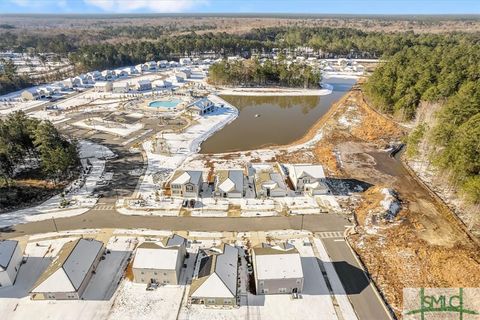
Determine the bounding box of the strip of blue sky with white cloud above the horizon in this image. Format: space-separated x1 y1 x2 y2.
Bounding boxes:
0 0 480 14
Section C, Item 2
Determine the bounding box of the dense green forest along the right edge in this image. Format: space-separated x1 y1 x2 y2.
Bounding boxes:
365 42 480 203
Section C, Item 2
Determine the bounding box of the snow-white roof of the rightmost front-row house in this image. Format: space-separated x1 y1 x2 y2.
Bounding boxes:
253 247 303 280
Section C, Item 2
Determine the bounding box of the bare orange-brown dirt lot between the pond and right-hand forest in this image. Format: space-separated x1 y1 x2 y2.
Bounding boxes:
298 85 480 316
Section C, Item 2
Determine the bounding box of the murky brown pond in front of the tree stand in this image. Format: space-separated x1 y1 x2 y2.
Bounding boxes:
200 78 355 154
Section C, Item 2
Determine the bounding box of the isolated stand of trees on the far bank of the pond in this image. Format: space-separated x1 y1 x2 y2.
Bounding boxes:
208 59 321 88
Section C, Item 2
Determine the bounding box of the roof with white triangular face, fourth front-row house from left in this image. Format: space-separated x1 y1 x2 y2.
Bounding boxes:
190 244 238 298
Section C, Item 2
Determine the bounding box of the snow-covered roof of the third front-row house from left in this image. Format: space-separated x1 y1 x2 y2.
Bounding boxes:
133 242 179 270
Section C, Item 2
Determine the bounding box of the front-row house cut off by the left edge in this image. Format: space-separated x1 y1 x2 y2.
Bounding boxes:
0 240 23 288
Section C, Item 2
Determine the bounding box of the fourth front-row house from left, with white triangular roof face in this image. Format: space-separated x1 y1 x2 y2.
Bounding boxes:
189 243 238 306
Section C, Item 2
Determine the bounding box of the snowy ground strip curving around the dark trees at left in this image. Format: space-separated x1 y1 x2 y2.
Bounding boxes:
0 141 113 227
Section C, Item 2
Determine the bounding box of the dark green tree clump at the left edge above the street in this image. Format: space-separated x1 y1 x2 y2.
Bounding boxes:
0 111 80 186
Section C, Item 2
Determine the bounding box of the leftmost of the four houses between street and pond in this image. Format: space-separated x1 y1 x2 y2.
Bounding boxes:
170 170 203 198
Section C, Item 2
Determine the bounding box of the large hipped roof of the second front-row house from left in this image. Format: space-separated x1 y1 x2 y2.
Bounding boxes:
32 239 103 293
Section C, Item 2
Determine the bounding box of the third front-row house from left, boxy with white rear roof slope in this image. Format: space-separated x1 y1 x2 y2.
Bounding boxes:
132 235 187 284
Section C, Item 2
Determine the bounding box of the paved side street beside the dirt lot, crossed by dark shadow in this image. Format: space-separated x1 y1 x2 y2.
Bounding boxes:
322 238 391 320
